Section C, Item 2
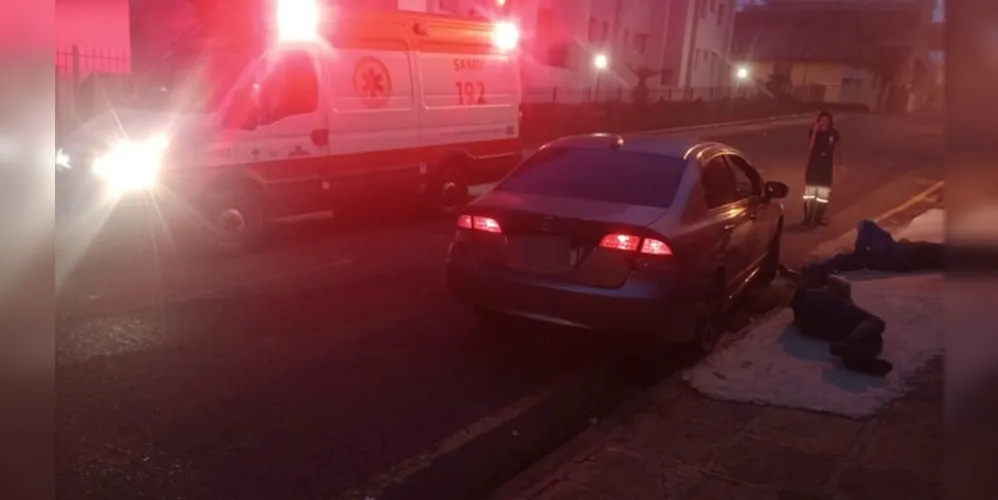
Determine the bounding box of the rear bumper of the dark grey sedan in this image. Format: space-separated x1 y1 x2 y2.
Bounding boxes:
447 244 692 342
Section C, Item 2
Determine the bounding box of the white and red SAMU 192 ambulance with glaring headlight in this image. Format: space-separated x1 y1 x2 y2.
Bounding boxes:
56 0 523 251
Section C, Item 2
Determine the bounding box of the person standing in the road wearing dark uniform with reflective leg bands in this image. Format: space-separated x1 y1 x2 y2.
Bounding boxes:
804 111 842 225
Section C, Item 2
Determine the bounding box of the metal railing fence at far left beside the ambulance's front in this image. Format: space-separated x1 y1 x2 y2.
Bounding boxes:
55 45 132 139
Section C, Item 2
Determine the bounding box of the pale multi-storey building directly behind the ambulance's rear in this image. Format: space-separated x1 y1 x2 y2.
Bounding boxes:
398 0 735 101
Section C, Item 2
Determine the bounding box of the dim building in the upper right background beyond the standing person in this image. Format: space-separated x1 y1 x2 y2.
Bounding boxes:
733 0 938 111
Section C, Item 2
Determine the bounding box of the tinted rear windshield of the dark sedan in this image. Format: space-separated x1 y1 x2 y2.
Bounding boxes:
496 148 687 208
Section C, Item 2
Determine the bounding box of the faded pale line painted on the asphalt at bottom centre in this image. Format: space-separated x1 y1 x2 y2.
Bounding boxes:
337 379 570 500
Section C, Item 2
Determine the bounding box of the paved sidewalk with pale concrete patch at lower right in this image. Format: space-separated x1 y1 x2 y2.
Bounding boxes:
494 211 943 500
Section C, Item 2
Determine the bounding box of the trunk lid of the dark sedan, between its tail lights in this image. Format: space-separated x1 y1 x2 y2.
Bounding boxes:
474 191 666 288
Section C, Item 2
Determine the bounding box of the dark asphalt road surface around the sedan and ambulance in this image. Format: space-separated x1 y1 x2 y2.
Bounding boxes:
56 116 943 500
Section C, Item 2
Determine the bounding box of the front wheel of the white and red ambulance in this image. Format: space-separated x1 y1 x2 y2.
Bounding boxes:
202 188 266 253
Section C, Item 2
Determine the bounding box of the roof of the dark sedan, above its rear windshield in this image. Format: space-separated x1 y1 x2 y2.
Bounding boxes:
541 134 741 164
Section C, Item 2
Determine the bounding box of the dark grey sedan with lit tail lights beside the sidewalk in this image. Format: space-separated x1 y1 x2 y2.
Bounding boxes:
447 134 788 353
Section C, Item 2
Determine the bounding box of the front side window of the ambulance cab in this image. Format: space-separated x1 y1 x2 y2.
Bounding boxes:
259 51 319 124
